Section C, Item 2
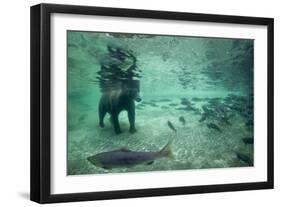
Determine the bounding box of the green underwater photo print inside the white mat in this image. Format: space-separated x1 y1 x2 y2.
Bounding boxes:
67 31 254 175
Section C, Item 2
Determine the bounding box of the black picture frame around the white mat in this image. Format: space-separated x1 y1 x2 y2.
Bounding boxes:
30 4 274 203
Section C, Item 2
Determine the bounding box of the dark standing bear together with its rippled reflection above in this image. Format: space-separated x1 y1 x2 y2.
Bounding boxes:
97 45 141 134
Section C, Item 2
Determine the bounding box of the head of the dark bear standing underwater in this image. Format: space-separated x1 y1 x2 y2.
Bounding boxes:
122 80 141 102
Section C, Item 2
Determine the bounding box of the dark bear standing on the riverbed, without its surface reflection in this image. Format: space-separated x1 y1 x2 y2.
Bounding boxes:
99 80 141 134
